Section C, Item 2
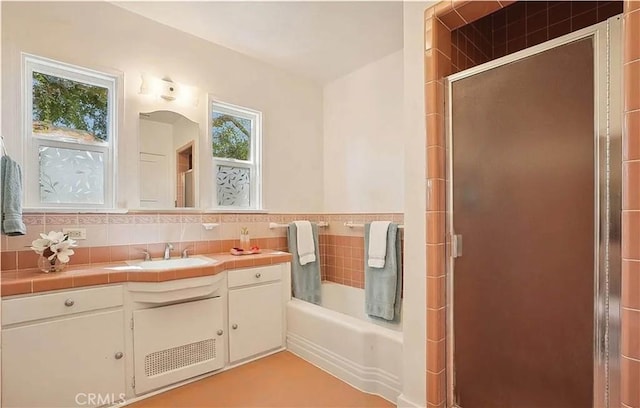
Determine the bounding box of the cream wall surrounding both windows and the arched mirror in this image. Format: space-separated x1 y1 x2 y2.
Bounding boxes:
2 2 323 212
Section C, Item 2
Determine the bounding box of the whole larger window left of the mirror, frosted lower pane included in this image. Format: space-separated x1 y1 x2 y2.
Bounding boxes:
23 55 117 208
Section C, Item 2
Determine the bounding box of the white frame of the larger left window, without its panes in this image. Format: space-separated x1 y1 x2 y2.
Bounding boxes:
21 53 119 210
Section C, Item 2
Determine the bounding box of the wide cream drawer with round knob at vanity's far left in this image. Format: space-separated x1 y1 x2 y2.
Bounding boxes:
2 285 123 326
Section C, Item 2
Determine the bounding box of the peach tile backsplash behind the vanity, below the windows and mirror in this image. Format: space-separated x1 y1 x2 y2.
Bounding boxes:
1 213 290 272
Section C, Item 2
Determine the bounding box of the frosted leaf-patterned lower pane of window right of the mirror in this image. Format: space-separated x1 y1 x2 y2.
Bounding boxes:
216 166 251 207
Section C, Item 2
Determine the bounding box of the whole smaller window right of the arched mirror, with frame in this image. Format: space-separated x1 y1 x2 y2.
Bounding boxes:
210 101 262 210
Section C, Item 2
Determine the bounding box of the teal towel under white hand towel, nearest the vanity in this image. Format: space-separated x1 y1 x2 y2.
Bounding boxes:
287 222 322 305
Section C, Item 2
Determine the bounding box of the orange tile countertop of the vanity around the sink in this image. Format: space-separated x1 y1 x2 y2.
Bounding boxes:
0 250 291 297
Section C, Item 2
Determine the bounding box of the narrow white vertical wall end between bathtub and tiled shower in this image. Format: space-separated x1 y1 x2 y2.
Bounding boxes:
398 1 435 407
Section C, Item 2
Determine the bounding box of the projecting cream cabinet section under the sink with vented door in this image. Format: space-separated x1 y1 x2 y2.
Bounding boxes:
127 274 226 395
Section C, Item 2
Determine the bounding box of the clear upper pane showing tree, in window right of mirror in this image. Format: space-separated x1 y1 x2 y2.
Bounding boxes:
212 112 251 160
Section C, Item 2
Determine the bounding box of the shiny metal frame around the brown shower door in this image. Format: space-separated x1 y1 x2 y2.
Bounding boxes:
444 15 623 408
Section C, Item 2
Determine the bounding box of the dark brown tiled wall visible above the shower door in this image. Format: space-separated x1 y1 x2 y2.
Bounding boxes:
451 1 623 72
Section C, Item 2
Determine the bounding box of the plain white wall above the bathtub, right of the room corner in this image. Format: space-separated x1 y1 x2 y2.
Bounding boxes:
323 50 404 212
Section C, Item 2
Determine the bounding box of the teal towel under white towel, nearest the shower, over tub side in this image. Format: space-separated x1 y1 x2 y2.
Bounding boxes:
364 223 402 321
